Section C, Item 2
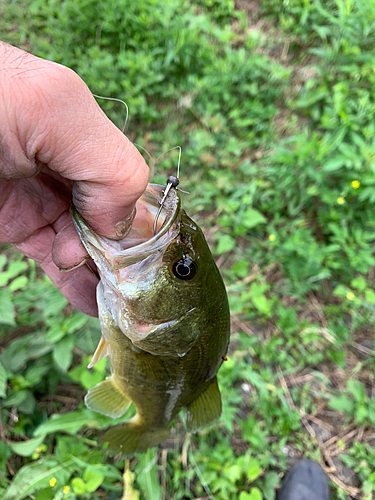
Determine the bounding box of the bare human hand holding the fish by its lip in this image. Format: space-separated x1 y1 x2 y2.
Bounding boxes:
0 42 149 316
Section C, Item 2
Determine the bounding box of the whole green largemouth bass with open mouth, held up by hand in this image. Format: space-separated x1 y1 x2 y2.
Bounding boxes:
71 184 230 457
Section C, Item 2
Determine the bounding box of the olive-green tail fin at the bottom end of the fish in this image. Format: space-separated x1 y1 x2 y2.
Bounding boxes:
99 416 170 456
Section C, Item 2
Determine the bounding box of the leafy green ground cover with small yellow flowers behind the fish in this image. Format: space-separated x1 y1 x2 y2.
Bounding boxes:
0 0 375 500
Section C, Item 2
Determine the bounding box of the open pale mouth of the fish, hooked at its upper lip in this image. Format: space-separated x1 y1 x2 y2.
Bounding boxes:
70 184 181 272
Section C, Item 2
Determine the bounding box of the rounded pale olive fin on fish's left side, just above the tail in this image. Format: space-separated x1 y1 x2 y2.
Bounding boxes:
85 377 131 418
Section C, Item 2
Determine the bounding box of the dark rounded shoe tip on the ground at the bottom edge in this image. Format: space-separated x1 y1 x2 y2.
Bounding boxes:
277 458 330 500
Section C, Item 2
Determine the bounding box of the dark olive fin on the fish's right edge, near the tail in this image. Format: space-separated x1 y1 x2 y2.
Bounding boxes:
186 377 221 432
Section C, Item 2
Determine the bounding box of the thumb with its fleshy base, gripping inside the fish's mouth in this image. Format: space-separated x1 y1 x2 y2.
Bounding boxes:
6 42 149 239
